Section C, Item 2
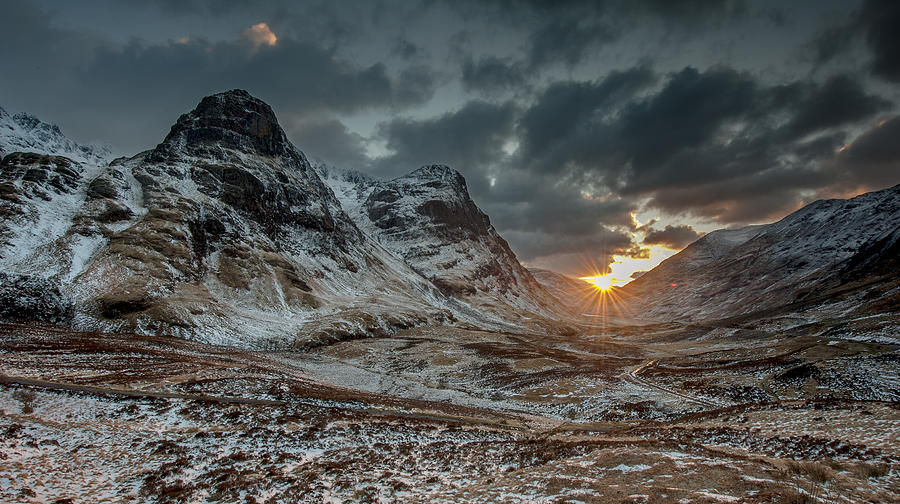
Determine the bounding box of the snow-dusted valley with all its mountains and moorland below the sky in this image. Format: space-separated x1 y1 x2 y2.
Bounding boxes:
0 90 900 504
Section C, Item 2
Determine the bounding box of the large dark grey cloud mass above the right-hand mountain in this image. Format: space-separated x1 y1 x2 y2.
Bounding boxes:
520 63 891 223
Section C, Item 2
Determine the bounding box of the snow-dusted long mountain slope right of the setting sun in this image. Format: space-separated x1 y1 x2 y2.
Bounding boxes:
621 186 900 320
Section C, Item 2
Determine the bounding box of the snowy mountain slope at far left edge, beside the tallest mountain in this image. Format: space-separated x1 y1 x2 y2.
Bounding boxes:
0 109 109 312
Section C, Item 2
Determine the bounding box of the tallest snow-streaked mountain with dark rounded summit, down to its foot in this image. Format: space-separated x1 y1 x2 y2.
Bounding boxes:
0 90 568 348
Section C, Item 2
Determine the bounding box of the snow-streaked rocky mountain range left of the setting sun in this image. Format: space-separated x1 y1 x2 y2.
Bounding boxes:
0 90 568 348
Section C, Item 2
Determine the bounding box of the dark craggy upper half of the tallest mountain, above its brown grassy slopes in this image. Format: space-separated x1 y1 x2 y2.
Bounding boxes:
135 90 361 260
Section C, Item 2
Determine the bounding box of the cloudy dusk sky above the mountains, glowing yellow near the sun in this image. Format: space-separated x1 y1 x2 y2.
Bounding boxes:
0 0 900 281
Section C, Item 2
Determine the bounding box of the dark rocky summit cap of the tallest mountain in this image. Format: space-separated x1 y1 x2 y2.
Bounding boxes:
156 89 292 157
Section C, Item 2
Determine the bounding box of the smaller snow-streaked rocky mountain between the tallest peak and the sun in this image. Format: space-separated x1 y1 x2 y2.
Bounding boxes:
323 165 564 317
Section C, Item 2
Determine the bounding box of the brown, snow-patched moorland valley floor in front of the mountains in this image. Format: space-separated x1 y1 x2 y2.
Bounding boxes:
0 324 900 503
